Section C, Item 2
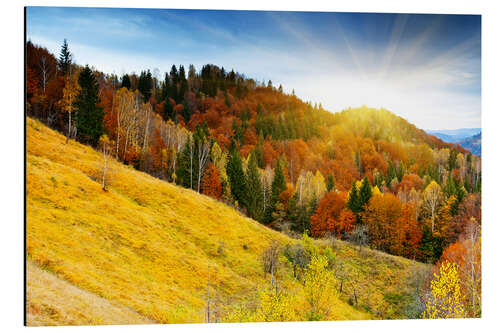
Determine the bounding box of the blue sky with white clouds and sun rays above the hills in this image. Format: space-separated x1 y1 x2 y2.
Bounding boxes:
26 7 481 129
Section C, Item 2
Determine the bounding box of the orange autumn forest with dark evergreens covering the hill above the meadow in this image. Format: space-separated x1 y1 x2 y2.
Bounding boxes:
26 40 481 321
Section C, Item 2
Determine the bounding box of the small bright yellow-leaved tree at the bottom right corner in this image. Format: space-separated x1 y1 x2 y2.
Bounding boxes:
423 261 465 319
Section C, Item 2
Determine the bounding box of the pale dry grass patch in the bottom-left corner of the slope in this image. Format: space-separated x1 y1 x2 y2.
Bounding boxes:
26 261 153 326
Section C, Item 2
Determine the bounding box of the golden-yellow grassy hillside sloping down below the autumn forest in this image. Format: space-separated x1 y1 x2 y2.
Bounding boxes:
26 118 425 325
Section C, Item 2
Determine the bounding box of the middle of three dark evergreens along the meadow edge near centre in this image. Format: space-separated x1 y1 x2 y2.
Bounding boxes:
246 152 264 221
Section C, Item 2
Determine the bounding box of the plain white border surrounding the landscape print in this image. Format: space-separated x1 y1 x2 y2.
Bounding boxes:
0 0 500 332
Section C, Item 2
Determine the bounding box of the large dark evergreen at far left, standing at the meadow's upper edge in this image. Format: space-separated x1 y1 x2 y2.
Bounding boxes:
75 65 104 146
